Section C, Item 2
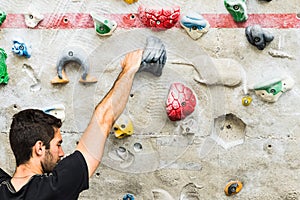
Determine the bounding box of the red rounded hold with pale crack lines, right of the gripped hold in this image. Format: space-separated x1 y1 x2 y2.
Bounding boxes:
166 83 197 121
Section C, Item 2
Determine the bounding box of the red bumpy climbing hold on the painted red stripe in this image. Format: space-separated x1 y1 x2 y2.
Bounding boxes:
138 5 180 29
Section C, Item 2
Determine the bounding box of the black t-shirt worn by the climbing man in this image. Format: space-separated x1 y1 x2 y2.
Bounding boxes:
0 151 89 200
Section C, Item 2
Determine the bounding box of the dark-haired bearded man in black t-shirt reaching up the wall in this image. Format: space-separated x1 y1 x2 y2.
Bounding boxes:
0 50 142 200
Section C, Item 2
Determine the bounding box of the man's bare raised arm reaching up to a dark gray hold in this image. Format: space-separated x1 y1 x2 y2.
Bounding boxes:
77 50 142 177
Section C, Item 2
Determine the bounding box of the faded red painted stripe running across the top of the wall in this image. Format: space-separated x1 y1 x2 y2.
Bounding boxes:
0 13 300 29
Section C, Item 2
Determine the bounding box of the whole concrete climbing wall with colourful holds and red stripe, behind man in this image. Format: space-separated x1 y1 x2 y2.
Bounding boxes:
0 0 300 200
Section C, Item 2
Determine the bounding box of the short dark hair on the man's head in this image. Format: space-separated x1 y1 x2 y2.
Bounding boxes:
9 109 62 166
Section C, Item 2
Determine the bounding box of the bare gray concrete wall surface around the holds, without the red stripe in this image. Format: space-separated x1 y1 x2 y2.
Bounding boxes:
0 0 300 200
